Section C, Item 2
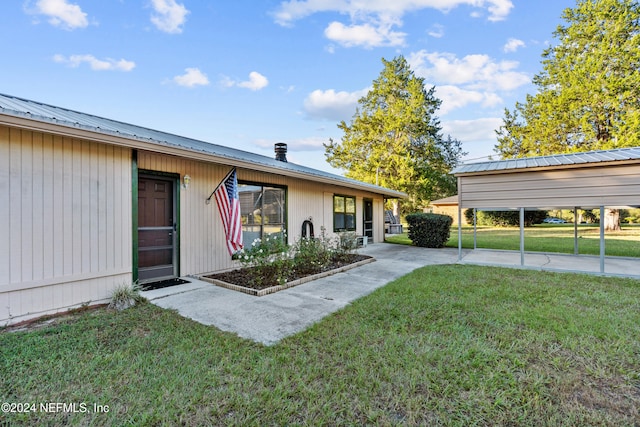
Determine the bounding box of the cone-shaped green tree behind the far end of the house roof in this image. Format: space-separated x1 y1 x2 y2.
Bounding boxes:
325 56 463 211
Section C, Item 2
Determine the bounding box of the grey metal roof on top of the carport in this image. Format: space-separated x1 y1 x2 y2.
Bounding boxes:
451 147 640 175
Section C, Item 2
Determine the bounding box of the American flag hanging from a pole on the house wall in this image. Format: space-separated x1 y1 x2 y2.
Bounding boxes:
213 168 242 255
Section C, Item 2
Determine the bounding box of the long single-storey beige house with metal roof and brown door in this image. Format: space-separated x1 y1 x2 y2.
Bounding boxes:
0 95 406 325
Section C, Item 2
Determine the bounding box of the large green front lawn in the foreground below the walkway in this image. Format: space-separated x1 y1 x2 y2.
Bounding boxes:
0 265 640 426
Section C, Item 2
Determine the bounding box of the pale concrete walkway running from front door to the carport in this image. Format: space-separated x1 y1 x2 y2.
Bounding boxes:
143 243 640 345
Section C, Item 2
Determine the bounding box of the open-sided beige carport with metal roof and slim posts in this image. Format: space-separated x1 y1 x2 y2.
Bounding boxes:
452 147 640 274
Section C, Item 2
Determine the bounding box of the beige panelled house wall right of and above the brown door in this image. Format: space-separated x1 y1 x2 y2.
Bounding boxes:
138 151 384 276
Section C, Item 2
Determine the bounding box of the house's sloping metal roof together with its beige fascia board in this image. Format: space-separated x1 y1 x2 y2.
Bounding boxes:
0 94 407 198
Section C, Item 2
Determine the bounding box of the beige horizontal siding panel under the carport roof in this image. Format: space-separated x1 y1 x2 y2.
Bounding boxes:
458 164 640 209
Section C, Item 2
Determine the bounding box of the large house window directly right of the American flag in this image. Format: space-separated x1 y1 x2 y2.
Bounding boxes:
238 183 287 247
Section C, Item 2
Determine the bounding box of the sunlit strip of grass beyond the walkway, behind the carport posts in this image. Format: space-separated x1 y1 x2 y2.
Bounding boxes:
386 224 640 257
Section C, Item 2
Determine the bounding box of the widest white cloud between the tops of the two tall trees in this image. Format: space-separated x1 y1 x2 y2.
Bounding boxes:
407 50 531 91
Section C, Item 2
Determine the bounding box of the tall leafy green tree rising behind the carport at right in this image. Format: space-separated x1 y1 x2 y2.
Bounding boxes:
495 0 640 229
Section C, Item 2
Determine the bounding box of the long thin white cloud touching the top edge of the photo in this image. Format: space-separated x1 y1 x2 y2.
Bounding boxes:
273 0 513 26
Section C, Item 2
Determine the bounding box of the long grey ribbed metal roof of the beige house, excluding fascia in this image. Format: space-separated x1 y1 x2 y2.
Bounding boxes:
0 94 406 198
